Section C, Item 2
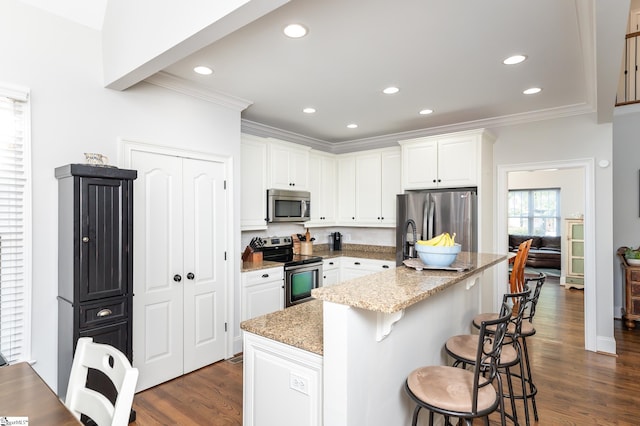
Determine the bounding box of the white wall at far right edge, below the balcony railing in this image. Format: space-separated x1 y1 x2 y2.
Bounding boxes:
612 105 640 318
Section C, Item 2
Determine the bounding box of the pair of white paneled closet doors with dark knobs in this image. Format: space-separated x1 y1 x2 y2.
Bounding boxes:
130 151 227 391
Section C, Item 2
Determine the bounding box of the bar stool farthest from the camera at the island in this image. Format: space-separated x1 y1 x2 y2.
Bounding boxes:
473 272 547 425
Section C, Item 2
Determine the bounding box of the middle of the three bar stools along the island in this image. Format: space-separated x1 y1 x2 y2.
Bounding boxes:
445 289 530 425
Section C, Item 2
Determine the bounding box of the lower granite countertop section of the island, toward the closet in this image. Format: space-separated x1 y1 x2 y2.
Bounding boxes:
240 300 323 355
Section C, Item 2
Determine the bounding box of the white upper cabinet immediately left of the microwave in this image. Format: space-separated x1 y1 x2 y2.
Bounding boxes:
240 134 267 231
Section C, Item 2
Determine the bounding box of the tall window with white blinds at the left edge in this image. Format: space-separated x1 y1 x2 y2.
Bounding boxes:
0 86 31 362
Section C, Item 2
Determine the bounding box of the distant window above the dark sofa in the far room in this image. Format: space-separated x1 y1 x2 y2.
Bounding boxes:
508 188 560 236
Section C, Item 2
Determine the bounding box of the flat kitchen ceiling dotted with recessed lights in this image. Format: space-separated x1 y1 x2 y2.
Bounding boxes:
164 0 594 143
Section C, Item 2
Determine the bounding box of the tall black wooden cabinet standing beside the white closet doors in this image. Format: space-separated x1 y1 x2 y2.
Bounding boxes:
55 164 137 417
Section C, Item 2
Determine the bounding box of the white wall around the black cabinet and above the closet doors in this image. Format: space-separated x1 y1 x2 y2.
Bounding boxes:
0 0 240 389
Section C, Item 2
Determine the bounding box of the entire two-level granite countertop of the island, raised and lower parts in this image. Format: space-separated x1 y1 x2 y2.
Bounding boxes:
240 252 508 355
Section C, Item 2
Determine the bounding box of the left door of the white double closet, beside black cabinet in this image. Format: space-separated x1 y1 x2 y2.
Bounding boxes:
131 151 185 390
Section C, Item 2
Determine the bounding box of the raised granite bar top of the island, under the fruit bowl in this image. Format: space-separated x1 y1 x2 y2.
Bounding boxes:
311 252 507 314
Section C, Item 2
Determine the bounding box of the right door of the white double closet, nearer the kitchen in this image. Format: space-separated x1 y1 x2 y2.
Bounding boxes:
183 159 227 373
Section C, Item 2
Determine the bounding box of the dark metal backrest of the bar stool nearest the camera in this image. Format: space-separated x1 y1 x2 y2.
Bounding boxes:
472 303 511 413
